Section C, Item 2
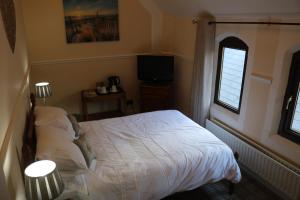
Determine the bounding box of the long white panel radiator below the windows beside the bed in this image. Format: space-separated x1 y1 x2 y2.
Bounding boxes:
206 120 300 200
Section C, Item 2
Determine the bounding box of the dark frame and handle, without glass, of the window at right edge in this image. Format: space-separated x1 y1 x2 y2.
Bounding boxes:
278 50 300 144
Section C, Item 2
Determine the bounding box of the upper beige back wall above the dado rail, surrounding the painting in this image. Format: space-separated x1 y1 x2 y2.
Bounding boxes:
23 0 151 63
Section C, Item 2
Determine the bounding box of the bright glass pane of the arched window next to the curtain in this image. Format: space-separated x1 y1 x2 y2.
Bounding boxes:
219 47 246 109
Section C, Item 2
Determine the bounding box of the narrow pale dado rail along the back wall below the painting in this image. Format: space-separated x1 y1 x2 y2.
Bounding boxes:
31 53 151 66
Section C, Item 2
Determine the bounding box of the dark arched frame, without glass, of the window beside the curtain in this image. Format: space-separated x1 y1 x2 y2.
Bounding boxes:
214 36 249 114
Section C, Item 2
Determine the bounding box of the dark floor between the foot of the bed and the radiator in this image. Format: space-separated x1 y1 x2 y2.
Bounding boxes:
163 172 282 200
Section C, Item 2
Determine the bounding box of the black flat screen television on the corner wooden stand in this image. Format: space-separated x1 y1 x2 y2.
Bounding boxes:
137 55 174 82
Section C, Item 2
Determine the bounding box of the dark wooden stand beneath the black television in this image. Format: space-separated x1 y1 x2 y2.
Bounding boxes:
140 82 174 112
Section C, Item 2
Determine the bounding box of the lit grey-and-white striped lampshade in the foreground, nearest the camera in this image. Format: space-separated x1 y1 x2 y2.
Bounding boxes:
25 160 64 200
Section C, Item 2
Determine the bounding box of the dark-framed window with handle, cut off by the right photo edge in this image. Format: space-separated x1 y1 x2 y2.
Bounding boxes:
278 51 300 144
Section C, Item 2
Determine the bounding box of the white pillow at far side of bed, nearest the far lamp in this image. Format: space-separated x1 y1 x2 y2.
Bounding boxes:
35 106 75 139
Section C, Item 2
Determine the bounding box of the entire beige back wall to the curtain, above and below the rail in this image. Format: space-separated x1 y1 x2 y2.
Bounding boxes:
23 0 195 114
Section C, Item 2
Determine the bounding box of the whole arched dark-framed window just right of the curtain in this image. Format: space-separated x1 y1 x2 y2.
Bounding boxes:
214 37 248 114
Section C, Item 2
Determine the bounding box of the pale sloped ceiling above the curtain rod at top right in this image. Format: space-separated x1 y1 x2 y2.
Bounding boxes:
153 0 300 16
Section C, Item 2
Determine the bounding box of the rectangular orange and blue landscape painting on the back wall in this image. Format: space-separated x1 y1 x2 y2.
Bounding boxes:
63 0 120 43
